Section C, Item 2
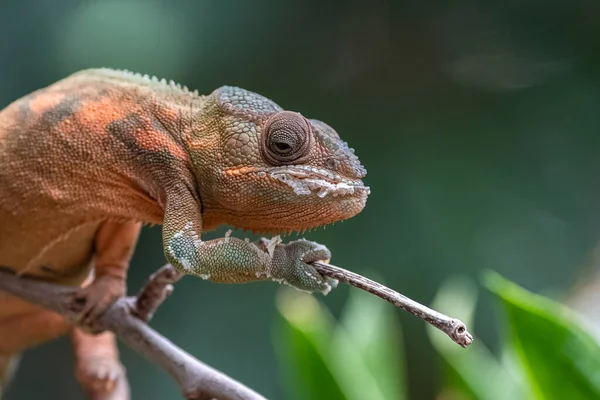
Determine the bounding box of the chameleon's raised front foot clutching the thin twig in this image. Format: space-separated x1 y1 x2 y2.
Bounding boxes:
270 239 338 294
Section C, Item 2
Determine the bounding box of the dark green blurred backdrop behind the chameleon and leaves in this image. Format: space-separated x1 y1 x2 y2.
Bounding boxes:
0 0 600 400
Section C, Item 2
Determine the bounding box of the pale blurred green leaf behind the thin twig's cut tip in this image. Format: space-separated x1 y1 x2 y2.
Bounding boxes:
427 278 531 400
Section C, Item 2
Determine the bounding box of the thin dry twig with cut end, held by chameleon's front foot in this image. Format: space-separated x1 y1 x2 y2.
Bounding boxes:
312 261 473 347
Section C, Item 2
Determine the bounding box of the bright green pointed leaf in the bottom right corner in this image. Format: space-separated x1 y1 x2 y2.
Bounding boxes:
485 272 600 400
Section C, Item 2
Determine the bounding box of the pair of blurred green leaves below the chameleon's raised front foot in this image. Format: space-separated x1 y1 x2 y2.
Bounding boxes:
278 282 405 400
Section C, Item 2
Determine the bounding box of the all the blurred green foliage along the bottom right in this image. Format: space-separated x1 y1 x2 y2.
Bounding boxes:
276 272 600 400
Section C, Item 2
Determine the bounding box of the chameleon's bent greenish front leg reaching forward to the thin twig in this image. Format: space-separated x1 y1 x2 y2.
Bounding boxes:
163 190 337 294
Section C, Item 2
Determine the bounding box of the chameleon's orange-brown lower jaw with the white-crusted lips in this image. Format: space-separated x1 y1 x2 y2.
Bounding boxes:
219 165 370 234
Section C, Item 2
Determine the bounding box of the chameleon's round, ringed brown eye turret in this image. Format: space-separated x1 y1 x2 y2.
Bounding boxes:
261 111 312 165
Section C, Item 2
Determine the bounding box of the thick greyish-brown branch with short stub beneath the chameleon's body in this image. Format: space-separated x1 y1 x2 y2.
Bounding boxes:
0 265 264 400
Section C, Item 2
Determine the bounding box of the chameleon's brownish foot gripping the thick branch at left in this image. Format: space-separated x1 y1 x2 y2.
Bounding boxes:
71 275 125 331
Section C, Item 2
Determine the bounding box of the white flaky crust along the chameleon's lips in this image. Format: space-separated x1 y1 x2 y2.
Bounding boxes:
269 165 371 198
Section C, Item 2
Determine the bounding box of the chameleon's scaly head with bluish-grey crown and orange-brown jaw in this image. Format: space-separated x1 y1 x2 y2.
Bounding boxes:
192 86 370 233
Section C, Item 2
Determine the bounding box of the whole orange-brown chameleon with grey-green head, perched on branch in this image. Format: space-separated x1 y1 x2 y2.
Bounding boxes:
0 68 370 398
